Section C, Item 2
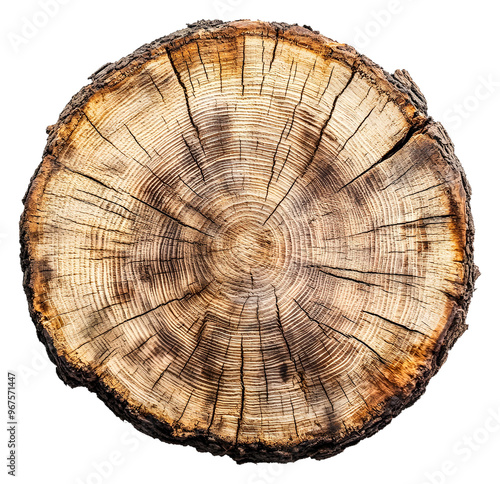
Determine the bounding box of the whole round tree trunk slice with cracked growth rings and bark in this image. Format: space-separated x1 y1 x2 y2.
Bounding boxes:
21 21 477 462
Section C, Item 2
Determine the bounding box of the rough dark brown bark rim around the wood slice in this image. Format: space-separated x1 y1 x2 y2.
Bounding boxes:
20 20 479 464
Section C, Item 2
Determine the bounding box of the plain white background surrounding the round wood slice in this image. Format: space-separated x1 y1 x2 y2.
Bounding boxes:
0 0 500 484
